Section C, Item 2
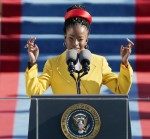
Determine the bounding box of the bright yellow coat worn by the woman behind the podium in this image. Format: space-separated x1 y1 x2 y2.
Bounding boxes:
25 51 133 97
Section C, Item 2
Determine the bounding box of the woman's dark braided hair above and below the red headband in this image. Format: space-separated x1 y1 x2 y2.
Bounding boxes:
64 4 90 33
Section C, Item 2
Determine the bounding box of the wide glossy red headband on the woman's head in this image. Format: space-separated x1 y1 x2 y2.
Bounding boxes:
65 9 92 24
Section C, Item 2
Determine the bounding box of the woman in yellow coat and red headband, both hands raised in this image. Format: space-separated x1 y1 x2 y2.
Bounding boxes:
25 5 133 97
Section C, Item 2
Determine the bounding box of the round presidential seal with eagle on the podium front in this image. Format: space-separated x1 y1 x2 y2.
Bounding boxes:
61 103 101 139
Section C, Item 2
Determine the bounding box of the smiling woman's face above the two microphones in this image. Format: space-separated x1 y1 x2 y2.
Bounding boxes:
65 24 88 53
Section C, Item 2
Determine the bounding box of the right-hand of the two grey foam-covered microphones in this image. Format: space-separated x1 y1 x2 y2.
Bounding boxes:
79 49 92 74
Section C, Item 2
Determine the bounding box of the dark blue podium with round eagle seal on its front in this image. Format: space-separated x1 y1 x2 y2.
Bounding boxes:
28 95 132 139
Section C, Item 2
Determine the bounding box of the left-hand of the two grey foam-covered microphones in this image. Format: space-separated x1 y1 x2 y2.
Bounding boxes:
66 49 78 75
